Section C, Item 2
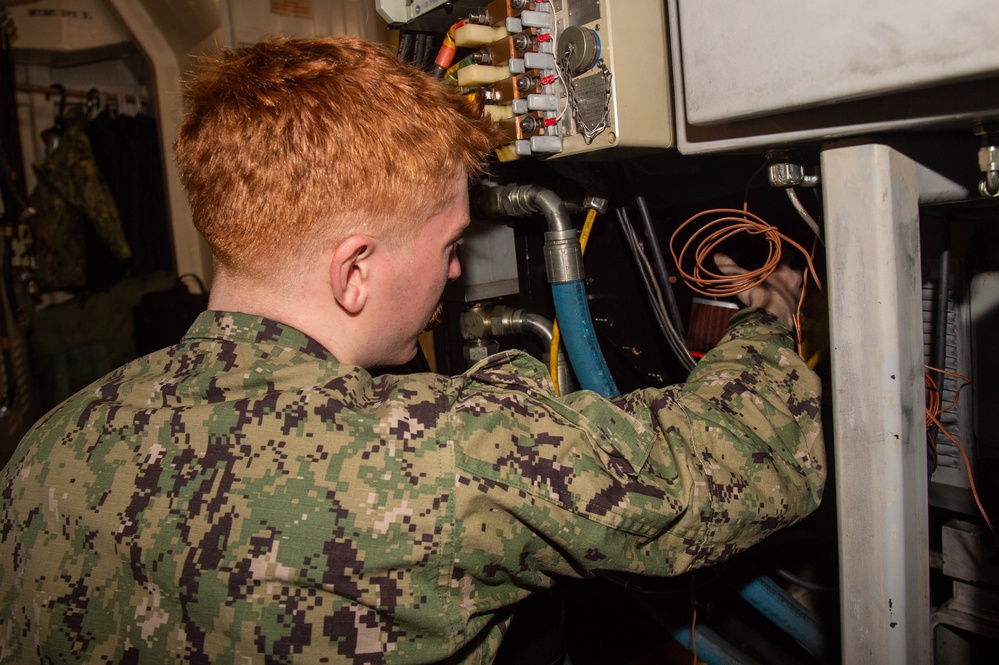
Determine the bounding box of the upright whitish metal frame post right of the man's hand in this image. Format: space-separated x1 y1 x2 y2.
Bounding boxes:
821 145 967 665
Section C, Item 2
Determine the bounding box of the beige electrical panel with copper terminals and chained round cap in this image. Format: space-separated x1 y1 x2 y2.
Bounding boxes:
380 0 674 161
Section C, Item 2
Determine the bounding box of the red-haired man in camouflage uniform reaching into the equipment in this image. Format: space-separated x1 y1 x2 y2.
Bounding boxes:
0 39 825 664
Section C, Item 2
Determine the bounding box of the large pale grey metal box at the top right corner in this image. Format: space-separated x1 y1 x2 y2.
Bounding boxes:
667 0 999 153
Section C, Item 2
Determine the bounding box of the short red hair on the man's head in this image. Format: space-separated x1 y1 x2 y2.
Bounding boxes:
174 38 496 277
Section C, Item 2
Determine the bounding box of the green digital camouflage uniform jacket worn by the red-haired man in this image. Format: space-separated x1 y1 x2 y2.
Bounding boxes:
0 310 825 665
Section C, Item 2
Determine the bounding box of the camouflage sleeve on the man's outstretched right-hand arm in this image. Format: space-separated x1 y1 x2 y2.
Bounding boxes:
452 310 825 605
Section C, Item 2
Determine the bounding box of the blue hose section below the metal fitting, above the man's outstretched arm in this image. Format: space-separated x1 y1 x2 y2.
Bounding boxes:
552 279 620 397
